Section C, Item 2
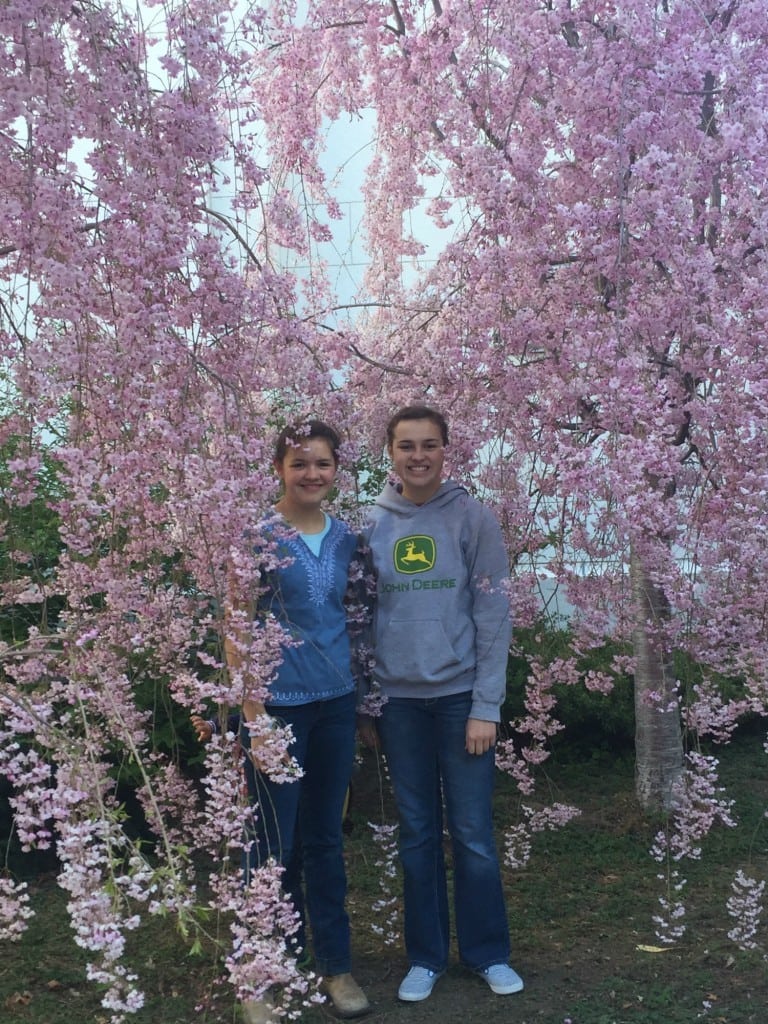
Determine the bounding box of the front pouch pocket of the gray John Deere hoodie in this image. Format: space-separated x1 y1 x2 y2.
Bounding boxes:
376 618 461 682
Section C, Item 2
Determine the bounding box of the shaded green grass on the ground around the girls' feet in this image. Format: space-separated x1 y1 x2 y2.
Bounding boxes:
0 734 768 1024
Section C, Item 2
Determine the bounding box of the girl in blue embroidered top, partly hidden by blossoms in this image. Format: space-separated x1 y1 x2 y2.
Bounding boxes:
227 420 369 1017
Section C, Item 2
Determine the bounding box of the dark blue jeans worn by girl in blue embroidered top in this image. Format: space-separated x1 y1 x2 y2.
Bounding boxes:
241 693 355 976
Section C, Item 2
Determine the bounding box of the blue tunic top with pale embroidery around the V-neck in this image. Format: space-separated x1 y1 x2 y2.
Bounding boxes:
257 516 358 708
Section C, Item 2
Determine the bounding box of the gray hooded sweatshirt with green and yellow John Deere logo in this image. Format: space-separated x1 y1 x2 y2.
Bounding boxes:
366 480 512 722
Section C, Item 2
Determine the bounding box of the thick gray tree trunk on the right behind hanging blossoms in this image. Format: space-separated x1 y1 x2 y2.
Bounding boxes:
630 550 683 811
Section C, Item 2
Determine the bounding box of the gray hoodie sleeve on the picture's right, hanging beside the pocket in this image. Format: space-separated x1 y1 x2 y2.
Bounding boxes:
467 505 512 722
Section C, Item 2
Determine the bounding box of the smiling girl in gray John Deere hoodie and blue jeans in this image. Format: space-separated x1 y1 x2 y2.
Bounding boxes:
362 406 523 1001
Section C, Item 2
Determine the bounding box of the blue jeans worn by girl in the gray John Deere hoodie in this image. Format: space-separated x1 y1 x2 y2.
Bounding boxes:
379 693 509 972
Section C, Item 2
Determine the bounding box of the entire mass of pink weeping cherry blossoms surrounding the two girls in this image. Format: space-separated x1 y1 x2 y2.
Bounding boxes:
0 0 768 1019
